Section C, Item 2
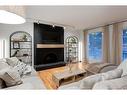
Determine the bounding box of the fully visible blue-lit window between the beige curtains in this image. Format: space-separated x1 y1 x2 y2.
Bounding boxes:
87 32 102 63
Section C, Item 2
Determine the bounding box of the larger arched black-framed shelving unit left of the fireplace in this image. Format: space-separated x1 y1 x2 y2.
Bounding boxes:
10 31 32 65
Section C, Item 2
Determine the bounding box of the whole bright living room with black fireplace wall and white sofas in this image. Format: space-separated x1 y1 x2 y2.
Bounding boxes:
0 1 127 93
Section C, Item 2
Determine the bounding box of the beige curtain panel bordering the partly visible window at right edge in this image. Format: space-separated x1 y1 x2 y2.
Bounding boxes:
111 23 123 64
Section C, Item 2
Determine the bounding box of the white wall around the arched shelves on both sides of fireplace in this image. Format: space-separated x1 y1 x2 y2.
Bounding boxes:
0 22 84 62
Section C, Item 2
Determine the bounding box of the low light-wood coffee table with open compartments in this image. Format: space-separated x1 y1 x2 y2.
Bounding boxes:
52 69 86 87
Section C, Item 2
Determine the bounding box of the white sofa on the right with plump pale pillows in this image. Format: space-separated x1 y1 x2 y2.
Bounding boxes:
58 60 127 90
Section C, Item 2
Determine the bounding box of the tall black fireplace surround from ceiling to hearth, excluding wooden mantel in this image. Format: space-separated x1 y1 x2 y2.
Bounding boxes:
34 23 65 71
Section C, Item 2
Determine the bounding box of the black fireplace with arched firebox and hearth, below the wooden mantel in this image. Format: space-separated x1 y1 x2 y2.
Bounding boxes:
35 48 65 70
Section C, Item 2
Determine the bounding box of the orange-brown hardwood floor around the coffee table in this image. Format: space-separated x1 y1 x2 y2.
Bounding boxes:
38 63 84 89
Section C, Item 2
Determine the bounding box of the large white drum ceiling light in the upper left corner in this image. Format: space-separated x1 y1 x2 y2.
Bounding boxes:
0 6 26 24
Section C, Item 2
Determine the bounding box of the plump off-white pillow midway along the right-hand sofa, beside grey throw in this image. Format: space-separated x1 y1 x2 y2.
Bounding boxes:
102 69 123 80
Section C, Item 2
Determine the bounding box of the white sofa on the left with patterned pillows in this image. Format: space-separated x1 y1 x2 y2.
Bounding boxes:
0 58 46 90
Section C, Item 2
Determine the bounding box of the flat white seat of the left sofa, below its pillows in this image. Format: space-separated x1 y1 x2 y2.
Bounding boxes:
4 68 46 90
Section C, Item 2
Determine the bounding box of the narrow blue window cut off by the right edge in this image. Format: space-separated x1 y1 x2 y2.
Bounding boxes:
122 29 127 60
